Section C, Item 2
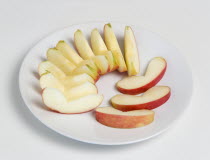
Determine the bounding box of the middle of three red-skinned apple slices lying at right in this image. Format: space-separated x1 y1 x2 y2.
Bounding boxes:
111 86 171 111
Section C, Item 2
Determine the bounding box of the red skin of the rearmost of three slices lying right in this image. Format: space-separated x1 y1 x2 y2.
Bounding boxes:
117 64 167 95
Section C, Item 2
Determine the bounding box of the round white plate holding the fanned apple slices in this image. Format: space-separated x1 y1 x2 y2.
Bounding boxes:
19 23 193 145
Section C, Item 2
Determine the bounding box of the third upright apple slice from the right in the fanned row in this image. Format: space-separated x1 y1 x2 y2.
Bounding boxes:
90 29 118 72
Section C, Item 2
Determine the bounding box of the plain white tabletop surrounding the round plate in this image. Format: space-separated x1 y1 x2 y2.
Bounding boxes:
0 0 210 160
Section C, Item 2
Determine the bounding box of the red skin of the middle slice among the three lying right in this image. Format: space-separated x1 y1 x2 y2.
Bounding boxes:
112 92 171 111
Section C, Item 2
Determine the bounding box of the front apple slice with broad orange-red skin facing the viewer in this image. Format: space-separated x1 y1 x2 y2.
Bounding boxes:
95 107 155 128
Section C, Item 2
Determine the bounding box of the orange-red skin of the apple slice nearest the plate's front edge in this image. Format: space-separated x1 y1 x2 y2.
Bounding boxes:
95 111 154 128
